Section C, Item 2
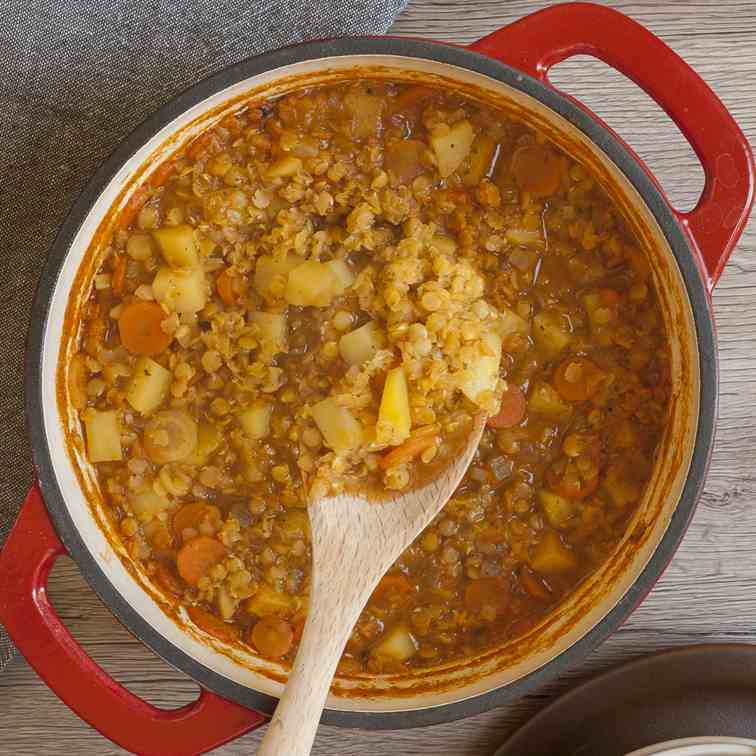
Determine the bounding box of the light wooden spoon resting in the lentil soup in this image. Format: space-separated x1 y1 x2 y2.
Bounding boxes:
257 415 486 756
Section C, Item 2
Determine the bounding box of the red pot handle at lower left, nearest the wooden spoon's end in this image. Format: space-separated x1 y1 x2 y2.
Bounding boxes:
0 483 266 756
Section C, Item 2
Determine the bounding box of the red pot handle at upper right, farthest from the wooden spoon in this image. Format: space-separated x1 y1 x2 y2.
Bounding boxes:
471 3 754 290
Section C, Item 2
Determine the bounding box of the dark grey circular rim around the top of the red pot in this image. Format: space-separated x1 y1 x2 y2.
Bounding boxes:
26 37 718 729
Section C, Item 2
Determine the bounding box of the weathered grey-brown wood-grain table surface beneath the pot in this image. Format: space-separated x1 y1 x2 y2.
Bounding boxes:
0 0 756 756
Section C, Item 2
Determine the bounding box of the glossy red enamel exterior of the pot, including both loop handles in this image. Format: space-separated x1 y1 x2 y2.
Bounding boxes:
0 3 754 756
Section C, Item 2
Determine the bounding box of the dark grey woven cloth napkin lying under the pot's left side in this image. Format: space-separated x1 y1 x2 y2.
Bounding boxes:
0 0 408 670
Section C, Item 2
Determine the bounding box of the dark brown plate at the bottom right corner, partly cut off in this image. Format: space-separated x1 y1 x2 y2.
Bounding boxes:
495 643 756 756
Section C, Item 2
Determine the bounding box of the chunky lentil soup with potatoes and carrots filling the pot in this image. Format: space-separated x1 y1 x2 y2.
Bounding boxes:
69 81 670 674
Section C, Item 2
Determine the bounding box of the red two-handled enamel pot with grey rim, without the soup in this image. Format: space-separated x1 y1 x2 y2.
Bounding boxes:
0 3 754 754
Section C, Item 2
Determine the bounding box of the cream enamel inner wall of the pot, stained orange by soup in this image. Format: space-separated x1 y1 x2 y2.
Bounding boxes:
42 55 700 712
